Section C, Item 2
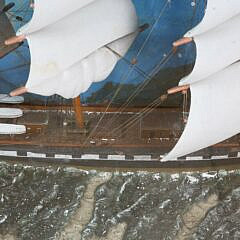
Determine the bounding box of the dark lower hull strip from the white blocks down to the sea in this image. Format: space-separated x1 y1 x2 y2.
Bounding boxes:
0 148 240 172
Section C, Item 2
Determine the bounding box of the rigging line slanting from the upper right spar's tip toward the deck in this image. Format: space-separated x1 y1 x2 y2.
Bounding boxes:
102 47 175 133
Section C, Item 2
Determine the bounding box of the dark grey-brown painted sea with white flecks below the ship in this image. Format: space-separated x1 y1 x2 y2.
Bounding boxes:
0 162 240 240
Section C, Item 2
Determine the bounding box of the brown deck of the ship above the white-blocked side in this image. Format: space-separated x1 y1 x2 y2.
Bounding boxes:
0 105 240 155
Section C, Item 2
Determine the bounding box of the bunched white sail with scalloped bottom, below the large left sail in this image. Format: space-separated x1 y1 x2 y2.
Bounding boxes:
26 33 136 98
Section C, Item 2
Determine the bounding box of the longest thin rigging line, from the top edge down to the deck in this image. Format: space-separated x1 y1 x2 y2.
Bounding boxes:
83 0 171 145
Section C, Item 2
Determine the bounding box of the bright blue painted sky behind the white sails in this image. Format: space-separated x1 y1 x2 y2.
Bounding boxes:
0 0 204 97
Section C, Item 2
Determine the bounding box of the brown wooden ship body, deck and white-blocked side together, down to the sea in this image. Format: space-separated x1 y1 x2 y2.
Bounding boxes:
0 105 240 170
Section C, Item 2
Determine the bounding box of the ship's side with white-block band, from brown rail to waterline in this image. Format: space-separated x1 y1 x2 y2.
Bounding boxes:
0 144 240 171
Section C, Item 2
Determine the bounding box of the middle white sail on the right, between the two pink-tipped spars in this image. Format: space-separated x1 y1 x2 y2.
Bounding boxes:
180 15 240 85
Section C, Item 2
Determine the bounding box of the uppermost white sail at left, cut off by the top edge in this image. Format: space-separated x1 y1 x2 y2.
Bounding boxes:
17 0 96 35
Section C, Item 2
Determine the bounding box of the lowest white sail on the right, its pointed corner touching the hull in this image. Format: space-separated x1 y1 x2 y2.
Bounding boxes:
163 62 240 160
